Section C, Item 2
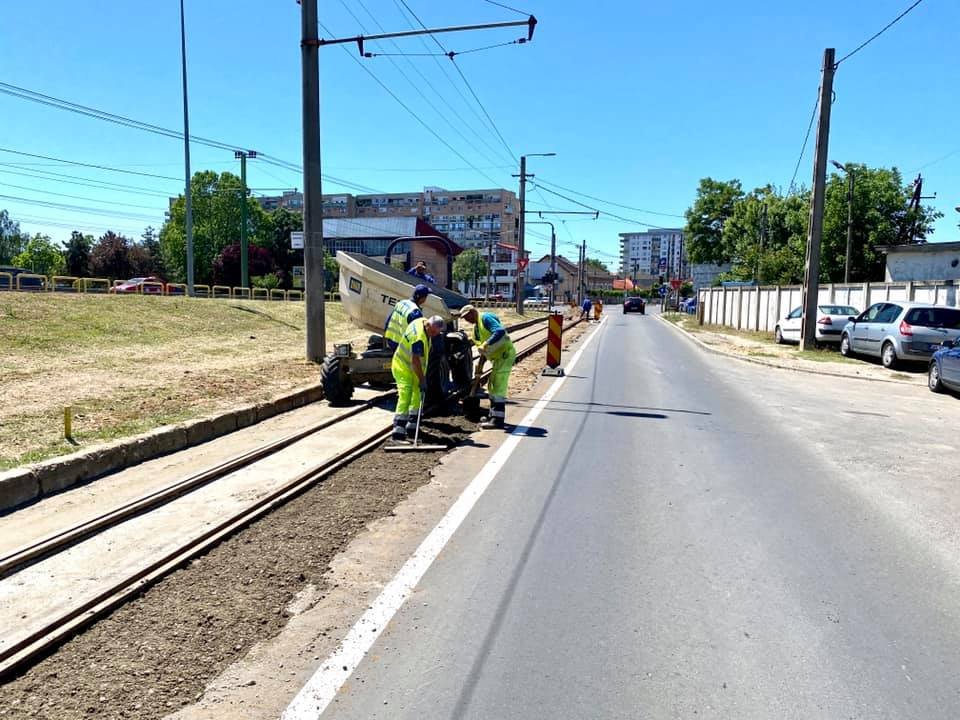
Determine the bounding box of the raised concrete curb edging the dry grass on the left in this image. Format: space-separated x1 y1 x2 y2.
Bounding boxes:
0 385 323 513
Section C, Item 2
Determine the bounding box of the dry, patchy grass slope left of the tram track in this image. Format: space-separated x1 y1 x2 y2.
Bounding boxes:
0 293 544 470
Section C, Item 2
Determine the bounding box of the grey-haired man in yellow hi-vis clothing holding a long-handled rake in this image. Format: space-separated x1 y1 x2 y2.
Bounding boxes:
390 315 445 442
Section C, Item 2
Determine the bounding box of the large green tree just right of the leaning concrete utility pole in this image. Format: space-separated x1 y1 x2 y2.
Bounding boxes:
820 164 943 282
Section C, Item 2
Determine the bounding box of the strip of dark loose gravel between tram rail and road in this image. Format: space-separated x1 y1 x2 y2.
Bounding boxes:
0 325 588 720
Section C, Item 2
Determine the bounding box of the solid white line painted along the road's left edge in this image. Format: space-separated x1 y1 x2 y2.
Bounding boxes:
282 318 607 720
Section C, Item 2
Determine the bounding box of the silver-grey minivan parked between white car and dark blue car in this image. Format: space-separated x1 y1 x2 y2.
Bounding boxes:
840 302 960 368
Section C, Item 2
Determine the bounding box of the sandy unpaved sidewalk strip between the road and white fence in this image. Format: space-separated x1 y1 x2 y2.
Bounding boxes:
657 313 927 387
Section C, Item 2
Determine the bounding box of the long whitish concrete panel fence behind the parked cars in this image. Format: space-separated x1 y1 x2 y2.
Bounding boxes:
697 280 960 332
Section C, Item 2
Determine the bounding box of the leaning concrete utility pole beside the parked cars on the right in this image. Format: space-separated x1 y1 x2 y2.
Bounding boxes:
800 48 836 350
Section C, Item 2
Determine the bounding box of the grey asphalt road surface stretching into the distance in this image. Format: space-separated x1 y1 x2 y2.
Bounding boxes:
323 313 960 720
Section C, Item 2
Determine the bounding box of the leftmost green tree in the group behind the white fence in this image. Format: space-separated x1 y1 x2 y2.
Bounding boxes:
684 177 743 265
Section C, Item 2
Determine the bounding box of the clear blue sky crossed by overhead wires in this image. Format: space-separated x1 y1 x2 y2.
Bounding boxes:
0 0 960 268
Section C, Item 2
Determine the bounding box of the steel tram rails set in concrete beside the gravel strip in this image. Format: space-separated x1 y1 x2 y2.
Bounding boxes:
0 320 581 678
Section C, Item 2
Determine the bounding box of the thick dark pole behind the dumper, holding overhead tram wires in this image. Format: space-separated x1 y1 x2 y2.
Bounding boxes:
300 0 327 363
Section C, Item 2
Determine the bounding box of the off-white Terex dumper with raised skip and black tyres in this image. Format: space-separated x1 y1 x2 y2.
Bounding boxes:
321 250 473 415
